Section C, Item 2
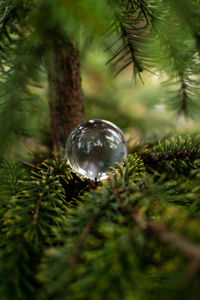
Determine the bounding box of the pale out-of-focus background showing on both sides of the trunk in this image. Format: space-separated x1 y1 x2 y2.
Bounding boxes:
21 43 199 160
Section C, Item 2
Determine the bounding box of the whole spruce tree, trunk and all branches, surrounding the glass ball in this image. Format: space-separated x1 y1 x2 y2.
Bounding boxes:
0 0 200 300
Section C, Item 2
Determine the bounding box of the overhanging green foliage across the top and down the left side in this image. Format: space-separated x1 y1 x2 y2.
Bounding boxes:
0 0 199 156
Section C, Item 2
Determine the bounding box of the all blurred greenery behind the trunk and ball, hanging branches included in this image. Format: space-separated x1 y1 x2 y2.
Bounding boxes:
0 0 200 160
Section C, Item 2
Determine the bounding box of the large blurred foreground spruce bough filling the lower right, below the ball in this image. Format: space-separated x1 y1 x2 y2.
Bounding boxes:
39 157 199 300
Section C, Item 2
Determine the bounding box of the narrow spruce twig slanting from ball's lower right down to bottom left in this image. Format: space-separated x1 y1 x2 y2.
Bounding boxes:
39 156 147 299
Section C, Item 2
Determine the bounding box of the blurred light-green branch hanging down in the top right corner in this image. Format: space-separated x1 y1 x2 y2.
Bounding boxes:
148 0 199 115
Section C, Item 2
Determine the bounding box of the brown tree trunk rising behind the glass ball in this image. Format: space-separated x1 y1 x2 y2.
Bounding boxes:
48 40 83 152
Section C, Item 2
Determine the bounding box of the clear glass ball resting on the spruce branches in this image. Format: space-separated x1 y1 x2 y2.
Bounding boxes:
66 120 128 181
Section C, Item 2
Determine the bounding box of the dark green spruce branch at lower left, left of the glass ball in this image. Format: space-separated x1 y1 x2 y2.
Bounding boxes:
0 158 90 299
